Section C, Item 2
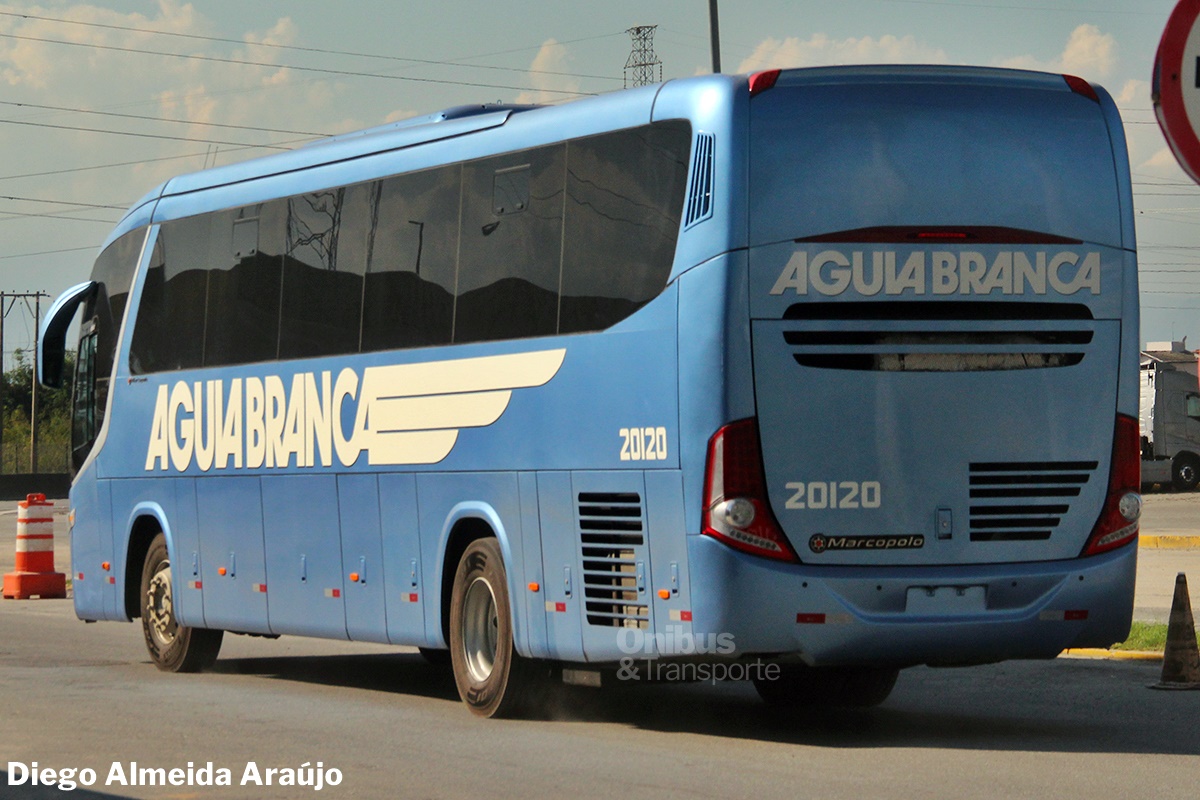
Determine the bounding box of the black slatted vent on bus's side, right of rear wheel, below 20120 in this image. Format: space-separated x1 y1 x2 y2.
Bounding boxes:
578 492 650 628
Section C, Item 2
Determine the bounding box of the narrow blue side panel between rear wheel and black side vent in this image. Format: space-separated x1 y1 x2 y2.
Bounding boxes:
538 473 583 661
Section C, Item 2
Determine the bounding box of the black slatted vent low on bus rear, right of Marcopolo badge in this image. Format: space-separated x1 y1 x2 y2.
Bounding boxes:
970 461 1098 542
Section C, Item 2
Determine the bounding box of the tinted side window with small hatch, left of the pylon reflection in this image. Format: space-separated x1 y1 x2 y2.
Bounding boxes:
202 200 288 367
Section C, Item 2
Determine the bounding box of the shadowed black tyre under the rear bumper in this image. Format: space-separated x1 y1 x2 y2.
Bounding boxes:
754 664 900 710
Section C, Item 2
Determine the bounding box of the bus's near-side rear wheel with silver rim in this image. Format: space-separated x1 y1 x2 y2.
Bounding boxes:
450 539 540 717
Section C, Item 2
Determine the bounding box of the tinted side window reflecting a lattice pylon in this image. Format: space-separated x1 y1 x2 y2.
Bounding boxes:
280 186 370 359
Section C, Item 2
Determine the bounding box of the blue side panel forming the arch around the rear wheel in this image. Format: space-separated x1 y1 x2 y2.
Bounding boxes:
416 473 528 646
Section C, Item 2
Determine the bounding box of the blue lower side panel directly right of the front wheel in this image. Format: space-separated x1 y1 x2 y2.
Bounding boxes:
196 476 271 633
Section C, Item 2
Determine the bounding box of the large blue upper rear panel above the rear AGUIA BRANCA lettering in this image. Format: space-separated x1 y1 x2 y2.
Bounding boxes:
750 83 1121 246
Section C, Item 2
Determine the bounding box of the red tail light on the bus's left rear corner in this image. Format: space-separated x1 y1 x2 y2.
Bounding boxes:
701 419 799 561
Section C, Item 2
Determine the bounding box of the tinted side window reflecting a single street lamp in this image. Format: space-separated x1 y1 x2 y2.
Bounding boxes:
362 166 462 351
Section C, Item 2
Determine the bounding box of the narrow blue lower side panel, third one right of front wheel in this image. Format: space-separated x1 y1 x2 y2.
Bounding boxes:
337 475 388 642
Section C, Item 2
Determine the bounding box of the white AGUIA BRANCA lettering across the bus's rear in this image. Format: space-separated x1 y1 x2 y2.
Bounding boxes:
770 249 1100 297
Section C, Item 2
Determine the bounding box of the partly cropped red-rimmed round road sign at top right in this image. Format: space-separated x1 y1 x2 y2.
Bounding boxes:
1151 0 1200 184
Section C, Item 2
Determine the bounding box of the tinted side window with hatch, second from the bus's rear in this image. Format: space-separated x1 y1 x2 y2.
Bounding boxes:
454 145 566 342
